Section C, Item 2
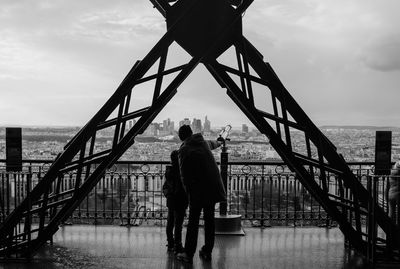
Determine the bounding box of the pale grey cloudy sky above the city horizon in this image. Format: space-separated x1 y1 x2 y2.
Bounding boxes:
0 0 400 126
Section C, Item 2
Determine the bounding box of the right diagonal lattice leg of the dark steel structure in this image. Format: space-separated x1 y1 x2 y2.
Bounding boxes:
206 37 400 253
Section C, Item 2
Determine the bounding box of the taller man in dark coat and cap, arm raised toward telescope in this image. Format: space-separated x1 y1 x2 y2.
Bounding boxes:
177 125 226 263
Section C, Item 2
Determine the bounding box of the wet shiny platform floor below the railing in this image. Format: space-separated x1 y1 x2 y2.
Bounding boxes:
0 225 363 269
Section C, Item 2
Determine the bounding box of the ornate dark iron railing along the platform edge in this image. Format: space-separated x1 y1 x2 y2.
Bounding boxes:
0 160 388 227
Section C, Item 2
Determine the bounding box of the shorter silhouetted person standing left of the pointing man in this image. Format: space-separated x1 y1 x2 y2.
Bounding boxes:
163 150 188 254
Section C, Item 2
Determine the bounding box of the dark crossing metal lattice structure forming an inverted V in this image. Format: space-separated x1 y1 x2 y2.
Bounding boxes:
0 0 400 258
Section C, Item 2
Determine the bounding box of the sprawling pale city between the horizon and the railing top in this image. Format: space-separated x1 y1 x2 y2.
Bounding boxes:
0 123 400 162
